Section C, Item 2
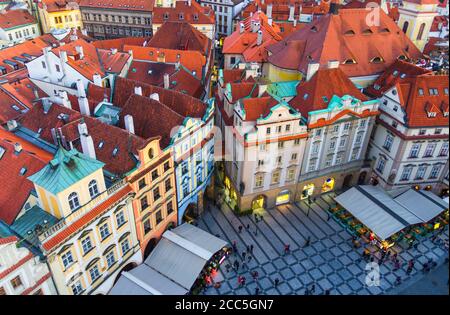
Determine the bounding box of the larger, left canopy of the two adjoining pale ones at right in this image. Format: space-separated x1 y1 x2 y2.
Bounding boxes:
335 186 411 240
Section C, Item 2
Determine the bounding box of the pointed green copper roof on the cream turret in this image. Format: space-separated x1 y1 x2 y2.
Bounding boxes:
28 146 105 194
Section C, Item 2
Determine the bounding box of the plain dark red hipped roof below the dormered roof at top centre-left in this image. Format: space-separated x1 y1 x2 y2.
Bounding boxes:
147 22 211 56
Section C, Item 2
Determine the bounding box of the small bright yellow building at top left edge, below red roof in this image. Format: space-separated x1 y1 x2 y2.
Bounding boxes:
38 0 83 33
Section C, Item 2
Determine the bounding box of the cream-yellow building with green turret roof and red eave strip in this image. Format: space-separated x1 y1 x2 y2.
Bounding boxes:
29 147 142 295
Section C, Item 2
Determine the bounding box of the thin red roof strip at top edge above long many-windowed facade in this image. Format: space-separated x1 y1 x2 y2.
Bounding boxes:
80 0 155 12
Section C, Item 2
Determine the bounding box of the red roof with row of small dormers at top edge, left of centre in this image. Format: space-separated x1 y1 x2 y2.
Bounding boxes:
153 0 215 25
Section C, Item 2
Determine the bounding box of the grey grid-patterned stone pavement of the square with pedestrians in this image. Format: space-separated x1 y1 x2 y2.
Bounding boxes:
198 193 448 295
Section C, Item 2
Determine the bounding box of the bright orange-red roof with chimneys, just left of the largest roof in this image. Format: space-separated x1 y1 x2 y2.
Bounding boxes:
222 12 281 62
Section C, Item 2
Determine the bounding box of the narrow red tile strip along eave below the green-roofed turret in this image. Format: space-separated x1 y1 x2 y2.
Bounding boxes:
42 185 133 252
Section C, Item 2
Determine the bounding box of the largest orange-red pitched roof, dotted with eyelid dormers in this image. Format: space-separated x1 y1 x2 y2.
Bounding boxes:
267 9 421 77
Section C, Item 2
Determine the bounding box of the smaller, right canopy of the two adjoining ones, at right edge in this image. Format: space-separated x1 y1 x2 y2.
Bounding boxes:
394 189 448 223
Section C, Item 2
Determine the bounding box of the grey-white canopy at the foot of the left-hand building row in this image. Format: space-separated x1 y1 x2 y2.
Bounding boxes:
109 223 227 295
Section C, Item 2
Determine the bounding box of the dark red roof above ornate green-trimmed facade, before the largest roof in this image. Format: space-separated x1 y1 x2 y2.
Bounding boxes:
289 68 368 118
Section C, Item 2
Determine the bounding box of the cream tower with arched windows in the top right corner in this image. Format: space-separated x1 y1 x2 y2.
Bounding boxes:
398 0 438 51
